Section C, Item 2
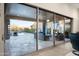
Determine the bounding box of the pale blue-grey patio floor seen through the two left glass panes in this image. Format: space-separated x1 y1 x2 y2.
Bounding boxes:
5 33 53 56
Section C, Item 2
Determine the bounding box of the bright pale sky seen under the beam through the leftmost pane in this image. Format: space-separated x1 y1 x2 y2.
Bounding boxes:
10 19 34 27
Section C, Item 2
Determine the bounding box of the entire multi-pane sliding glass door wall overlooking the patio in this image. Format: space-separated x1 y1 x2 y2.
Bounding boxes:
5 3 71 56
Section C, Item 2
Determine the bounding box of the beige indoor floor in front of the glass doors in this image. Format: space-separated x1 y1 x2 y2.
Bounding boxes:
28 42 73 56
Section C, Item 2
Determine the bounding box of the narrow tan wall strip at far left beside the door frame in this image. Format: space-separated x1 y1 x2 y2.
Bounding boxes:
0 3 4 56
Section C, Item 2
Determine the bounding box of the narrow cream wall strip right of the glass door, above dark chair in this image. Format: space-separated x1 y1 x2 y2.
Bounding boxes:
72 8 79 32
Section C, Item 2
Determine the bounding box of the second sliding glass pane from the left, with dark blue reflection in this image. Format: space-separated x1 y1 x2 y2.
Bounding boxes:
38 9 53 49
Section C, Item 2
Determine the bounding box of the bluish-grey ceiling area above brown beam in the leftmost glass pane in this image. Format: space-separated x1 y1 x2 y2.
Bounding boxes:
6 3 36 19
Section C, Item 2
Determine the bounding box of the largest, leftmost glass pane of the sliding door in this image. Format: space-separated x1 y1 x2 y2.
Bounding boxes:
5 3 37 56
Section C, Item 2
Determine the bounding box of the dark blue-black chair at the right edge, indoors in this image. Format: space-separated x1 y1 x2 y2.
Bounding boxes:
69 33 79 56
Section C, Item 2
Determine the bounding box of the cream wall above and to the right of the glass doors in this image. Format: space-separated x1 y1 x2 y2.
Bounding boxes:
30 3 79 32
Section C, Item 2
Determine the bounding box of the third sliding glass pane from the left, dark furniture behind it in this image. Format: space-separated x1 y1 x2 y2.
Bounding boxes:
54 15 64 45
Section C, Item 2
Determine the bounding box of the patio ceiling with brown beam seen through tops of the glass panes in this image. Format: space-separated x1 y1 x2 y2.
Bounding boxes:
5 3 63 21
